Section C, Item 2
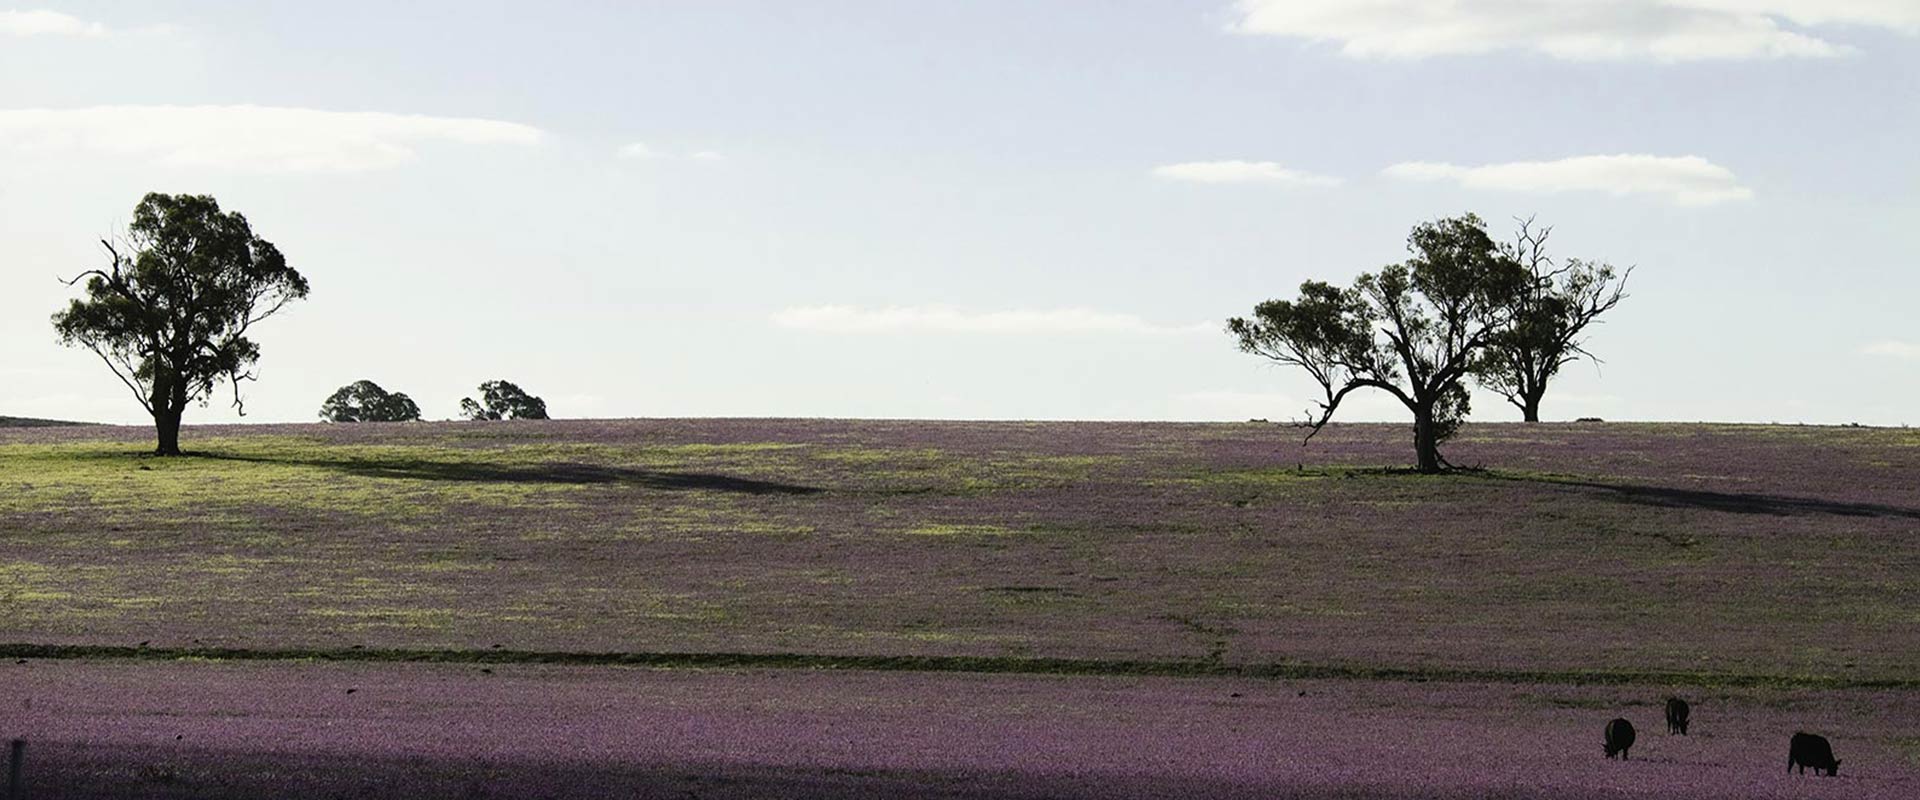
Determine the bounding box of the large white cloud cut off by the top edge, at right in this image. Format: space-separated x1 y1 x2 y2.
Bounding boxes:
1229 0 1920 61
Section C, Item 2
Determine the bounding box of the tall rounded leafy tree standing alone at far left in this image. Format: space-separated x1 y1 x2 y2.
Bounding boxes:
54 194 307 455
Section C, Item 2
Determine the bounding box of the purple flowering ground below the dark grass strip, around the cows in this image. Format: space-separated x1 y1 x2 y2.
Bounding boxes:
0 662 1920 800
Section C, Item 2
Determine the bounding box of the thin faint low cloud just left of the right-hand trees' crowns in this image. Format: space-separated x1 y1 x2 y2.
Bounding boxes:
772 305 1219 334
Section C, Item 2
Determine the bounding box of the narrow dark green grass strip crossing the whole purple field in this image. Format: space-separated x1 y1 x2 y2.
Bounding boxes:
0 645 1920 689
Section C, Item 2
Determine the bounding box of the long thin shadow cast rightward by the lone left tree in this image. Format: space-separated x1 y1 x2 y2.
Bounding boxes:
196 453 826 495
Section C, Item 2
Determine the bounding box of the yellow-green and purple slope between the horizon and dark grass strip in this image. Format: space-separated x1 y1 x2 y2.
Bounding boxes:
0 420 1920 683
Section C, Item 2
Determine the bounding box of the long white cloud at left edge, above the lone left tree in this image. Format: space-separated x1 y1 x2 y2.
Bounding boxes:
0 106 543 173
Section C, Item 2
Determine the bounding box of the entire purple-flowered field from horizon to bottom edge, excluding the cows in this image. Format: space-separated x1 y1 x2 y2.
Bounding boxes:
0 420 1920 798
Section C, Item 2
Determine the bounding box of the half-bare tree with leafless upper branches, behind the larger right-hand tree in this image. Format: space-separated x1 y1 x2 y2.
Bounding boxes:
1473 219 1634 422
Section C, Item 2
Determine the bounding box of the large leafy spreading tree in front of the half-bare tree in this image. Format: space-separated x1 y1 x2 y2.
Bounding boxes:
1227 213 1526 472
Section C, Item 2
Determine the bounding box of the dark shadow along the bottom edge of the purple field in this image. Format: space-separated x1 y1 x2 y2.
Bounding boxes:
0 731 1336 800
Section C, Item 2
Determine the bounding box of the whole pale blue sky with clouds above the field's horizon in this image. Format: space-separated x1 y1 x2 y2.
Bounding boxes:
0 0 1920 424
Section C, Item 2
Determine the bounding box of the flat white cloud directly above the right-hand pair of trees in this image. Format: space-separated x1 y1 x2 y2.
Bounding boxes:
1382 153 1753 205
